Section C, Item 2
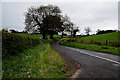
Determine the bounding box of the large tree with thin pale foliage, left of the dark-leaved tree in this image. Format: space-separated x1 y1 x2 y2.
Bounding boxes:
25 5 61 39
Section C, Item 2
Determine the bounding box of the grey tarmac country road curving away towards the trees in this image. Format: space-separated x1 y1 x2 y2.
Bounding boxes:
51 42 120 79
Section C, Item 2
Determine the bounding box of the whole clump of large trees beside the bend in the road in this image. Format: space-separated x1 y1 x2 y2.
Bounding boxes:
25 5 78 39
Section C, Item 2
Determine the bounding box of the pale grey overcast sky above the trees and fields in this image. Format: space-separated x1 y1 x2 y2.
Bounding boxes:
0 0 118 34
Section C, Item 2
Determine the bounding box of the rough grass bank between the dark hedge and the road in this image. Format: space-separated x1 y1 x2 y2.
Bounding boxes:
2 43 73 78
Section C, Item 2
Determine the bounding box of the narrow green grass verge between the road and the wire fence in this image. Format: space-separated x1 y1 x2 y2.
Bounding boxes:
60 41 120 55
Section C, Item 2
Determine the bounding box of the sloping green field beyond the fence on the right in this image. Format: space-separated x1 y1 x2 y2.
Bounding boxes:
76 32 120 46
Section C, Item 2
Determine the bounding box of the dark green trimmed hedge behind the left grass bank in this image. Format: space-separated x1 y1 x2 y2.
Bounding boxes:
2 32 40 56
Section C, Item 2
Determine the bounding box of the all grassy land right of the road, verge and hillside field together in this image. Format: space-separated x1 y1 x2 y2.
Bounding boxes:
60 32 120 55
